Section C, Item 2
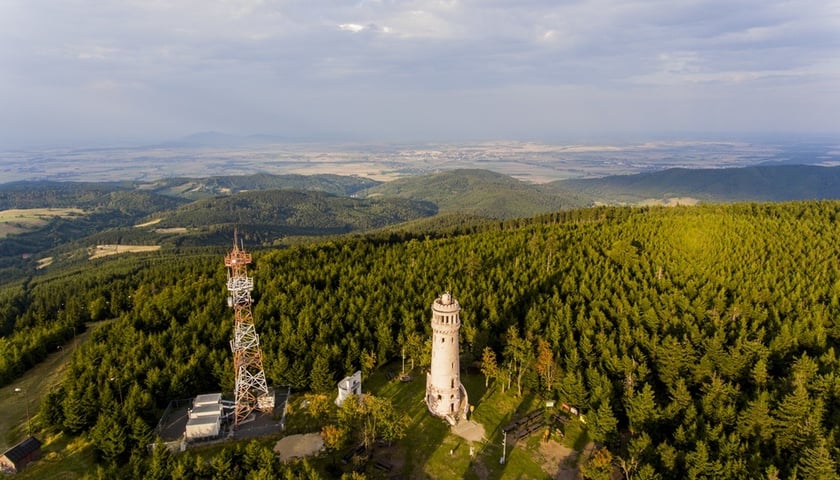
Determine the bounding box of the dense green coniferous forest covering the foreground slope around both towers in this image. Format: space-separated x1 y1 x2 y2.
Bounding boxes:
0 201 840 479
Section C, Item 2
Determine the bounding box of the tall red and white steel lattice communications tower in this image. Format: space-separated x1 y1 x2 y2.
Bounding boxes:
225 234 274 428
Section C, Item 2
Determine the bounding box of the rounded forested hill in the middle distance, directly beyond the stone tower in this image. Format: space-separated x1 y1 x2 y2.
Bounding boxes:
360 169 590 219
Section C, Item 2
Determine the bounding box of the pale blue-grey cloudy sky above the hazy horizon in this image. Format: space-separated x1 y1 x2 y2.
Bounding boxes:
0 0 840 147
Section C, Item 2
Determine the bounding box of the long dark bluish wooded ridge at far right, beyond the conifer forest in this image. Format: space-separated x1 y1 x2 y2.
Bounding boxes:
551 165 840 203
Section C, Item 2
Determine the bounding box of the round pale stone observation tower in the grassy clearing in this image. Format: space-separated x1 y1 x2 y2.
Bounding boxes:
426 292 468 425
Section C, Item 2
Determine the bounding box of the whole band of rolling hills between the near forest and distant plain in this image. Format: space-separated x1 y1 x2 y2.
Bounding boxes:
8 165 840 278
